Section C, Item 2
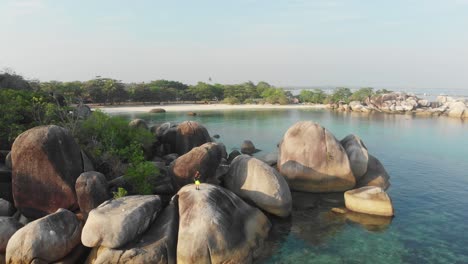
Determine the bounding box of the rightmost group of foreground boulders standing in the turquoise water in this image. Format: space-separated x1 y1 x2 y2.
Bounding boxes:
277 121 393 216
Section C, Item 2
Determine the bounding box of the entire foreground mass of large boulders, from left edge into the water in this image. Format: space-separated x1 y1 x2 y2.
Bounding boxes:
0 120 393 263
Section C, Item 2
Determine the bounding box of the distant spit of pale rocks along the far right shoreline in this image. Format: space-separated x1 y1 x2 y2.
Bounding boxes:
331 93 468 118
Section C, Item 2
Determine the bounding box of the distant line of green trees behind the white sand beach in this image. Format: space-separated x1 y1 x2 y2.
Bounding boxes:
0 73 389 105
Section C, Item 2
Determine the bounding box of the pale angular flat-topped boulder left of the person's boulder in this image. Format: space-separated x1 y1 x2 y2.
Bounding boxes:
81 195 161 248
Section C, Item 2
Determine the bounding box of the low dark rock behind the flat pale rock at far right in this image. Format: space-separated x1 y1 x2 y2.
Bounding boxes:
356 154 390 190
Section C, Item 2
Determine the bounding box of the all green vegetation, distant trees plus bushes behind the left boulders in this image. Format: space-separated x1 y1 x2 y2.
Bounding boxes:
0 69 396 197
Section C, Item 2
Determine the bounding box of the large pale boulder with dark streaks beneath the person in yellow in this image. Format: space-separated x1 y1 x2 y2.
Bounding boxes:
177 183 271 263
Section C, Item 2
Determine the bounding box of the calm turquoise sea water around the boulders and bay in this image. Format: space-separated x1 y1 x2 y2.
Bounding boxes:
111 109 468 263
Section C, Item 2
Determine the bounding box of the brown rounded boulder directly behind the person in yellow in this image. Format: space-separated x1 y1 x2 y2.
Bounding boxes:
169 142 223 189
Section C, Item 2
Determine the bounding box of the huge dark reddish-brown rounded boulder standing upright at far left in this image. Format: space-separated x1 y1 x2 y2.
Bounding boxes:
11 125 83 218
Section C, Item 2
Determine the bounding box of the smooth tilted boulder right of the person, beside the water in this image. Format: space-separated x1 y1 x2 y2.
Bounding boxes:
224 155 292 217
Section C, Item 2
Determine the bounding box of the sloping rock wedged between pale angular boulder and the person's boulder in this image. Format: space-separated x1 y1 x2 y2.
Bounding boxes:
86 196 179 264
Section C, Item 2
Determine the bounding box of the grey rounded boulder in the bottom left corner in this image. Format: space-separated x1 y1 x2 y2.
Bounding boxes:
6 209 81 263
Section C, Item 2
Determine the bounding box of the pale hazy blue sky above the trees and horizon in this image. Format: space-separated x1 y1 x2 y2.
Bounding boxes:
0 0 468 89
